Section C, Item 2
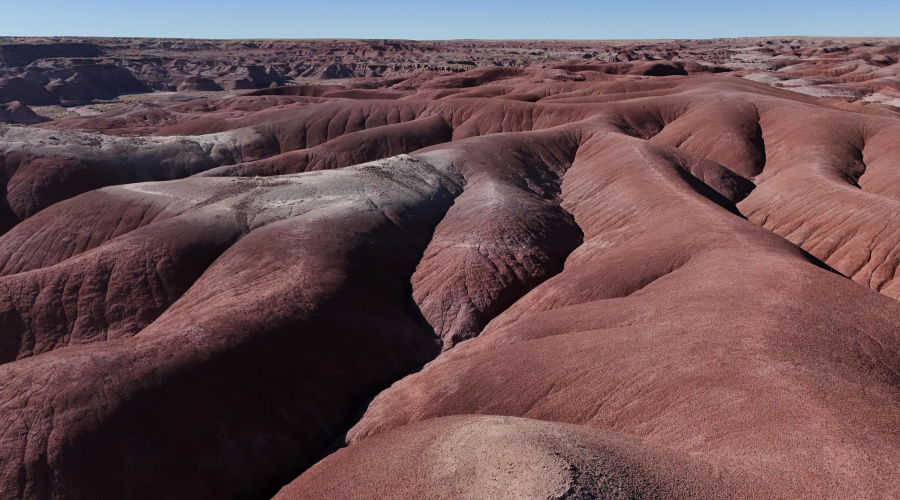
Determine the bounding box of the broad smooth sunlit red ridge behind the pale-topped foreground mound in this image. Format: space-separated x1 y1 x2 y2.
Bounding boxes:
336 124 900 497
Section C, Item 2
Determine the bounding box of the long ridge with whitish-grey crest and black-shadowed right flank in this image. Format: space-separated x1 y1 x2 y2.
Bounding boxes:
0 154 458 498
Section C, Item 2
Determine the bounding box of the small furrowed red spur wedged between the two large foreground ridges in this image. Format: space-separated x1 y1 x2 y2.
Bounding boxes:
412 130 582 349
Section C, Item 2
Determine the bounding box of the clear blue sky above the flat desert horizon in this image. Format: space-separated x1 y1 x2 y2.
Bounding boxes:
0 0 900 40
